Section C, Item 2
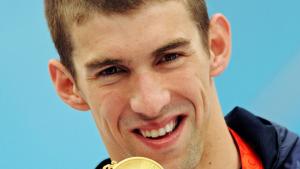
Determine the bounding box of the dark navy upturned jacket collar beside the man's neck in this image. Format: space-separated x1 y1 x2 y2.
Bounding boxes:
225 107 279 169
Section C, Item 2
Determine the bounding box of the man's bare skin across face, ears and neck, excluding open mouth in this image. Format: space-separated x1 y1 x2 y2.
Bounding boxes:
49 1 240 169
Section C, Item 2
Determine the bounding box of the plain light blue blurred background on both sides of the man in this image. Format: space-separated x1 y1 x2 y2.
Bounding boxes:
0 0 300 169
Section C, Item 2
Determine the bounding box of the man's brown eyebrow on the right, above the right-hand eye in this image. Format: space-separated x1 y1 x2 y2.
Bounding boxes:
152 38 190 56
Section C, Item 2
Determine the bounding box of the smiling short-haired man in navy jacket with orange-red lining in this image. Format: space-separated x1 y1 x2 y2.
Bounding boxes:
45 0 300 169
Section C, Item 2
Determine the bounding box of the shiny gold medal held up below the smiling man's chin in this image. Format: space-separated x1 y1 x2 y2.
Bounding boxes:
103 157 163 169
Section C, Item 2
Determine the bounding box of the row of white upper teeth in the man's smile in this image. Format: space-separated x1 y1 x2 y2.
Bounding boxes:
140 121 176 138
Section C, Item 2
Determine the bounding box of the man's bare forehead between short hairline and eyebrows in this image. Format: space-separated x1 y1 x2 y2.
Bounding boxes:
71 1 198 65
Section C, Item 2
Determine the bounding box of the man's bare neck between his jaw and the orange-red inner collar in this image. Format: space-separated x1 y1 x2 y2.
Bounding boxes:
197 83 241 169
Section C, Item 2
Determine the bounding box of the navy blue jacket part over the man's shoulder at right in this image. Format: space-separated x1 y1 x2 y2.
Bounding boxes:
225 107 300 169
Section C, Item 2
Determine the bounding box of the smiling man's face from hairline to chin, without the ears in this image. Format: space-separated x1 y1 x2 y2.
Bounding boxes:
72 1 212 169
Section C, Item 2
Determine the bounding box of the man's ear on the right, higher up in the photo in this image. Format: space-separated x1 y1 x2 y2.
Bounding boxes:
208 14 231 77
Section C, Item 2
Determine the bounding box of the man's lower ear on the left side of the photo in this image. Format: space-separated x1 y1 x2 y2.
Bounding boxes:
48 60 90 111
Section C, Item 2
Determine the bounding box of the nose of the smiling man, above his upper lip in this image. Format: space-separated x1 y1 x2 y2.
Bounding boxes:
130 73 171 118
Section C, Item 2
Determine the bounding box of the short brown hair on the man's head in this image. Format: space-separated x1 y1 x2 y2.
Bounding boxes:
44 0 209 77
